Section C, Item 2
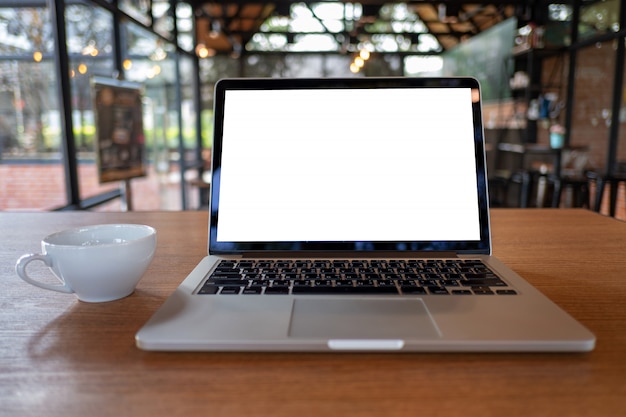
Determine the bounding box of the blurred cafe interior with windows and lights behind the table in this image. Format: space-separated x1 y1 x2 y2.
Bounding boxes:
0 0 626 220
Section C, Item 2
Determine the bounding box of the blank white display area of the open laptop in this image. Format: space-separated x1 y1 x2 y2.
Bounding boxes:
217 88 480 242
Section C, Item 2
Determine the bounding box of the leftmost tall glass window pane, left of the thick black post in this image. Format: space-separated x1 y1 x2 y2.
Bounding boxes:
0 7 67 211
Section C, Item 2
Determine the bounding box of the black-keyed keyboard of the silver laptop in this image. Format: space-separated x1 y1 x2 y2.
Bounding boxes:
198 259 517 295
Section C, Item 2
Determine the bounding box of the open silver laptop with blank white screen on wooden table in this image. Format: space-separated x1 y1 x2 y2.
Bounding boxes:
136 78 595 352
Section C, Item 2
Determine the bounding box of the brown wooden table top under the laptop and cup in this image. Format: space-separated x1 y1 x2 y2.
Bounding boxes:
0 209 626 417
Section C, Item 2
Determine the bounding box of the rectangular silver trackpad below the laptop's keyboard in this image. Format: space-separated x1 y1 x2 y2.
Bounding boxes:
289 298 440 339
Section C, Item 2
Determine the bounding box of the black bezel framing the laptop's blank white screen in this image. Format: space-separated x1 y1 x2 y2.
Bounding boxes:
209 77 491 255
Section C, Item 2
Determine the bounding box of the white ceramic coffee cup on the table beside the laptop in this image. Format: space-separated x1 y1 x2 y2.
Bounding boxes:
15 224 156 303
